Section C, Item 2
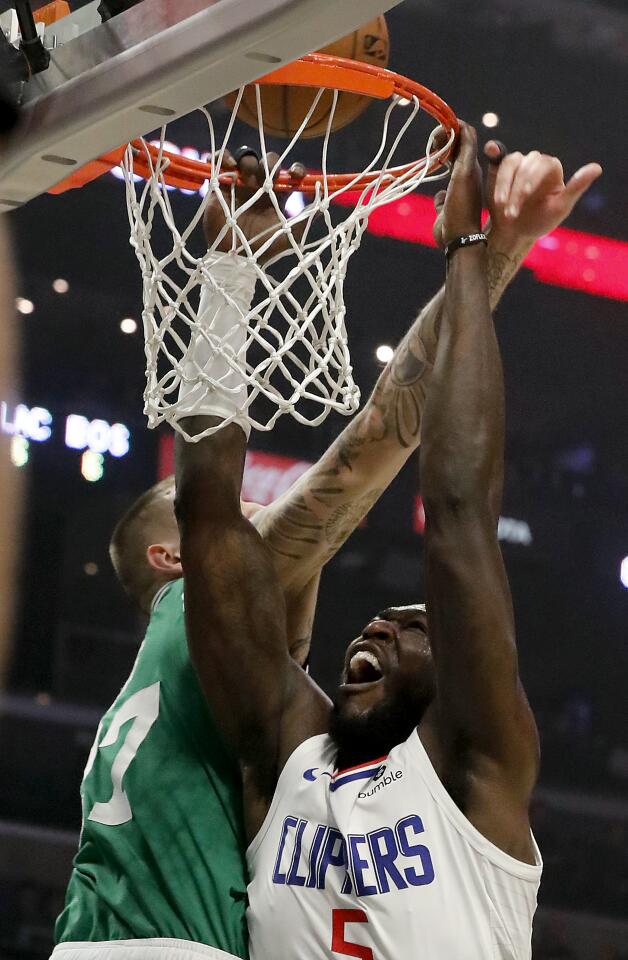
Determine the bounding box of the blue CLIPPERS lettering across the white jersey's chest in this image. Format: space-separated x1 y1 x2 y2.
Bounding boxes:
273 814 435 897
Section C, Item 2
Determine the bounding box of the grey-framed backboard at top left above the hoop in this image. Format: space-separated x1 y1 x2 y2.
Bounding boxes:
0 0 401 210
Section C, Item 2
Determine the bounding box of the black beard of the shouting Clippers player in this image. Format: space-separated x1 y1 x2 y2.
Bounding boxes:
329 690 431 770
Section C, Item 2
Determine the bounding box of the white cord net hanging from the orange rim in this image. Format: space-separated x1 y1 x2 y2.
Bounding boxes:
124 87 454 440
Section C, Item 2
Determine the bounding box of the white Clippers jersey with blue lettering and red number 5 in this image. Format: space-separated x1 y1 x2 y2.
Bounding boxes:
247 731 542 960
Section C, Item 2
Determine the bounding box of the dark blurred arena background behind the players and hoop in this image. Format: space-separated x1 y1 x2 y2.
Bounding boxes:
0 0 628 960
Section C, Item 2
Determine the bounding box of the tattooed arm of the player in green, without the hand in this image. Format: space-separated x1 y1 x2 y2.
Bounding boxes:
250 221 526 588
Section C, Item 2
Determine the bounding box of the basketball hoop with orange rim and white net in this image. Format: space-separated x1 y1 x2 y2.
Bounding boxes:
55 54 459 440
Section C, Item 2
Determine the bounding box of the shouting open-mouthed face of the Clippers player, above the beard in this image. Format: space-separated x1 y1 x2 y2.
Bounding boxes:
336 605 435 723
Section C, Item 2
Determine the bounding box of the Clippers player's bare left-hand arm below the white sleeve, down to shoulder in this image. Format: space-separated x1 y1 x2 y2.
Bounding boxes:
175 417 328 836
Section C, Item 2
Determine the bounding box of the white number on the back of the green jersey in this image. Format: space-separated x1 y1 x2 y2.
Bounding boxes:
85 681 159 827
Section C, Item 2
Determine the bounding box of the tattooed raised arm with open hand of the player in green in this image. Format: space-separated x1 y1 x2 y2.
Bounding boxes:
258 141 601 596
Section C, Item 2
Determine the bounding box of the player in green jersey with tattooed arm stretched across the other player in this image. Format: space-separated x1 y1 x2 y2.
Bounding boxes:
55 142 596 960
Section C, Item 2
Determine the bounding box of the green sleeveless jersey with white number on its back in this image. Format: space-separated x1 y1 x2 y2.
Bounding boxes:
56 580 248 958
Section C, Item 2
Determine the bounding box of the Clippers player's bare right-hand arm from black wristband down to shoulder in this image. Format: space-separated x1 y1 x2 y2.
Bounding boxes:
421 152 537 840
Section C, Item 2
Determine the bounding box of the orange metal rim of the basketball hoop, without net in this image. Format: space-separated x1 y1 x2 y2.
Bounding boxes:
49 53 460 194
